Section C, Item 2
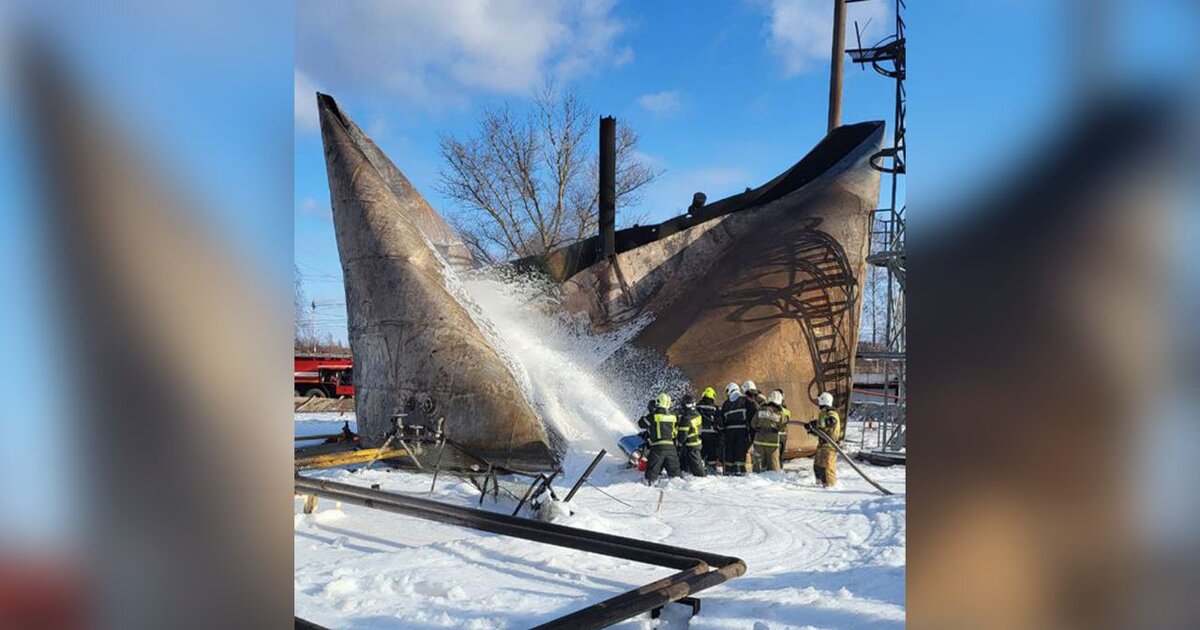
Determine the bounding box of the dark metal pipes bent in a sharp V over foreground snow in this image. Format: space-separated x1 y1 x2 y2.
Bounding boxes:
295 475 746 630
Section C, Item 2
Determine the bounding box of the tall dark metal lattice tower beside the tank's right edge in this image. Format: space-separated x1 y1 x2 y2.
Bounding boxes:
846 0 907 453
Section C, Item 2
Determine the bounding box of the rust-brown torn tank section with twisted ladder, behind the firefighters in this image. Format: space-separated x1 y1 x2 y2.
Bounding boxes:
544 122 883 456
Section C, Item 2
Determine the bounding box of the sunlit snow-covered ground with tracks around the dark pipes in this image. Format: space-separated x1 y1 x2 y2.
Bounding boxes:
295 414 905 629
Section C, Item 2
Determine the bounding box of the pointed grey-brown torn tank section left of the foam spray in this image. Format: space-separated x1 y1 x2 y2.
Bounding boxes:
317 90 560 470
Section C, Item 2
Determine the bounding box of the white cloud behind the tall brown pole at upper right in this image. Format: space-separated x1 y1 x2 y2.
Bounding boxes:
758 0 892 77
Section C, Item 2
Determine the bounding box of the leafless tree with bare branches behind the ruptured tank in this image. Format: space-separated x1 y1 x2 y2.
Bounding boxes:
440 85 661 263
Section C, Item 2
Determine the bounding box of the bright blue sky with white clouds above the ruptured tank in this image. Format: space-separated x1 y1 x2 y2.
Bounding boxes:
294 0 893 340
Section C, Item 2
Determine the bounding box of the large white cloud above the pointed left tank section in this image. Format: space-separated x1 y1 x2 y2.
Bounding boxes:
296 0 632 107
